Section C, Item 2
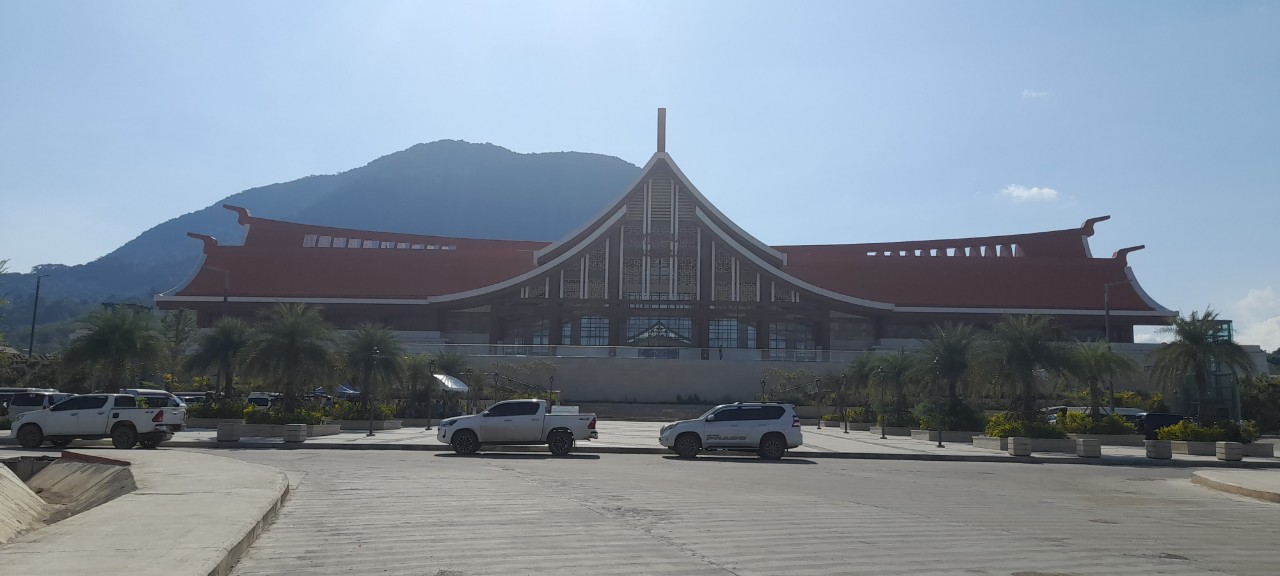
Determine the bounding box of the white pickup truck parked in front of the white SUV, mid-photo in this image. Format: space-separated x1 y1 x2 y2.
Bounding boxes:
435 399 599 456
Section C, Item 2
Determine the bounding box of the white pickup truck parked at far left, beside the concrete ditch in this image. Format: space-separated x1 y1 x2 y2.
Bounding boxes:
10 394 180 449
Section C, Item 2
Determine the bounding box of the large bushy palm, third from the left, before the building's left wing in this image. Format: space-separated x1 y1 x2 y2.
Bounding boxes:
242 303 335 412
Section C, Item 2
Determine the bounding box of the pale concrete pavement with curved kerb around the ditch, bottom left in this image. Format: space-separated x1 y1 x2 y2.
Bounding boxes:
0 448 289 576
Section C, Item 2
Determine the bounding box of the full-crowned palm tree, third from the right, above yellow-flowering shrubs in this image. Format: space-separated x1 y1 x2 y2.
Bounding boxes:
977 316 1071 421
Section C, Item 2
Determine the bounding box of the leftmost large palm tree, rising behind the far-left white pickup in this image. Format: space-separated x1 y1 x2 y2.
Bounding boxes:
64 306 160 392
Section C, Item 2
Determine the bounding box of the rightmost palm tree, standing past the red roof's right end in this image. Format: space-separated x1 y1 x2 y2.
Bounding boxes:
1151 308 1253 424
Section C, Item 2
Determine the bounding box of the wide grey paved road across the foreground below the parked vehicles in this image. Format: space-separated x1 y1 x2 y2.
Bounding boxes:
207 451 1280 576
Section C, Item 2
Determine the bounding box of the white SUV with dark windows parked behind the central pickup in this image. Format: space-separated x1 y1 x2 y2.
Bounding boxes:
658 402 804 460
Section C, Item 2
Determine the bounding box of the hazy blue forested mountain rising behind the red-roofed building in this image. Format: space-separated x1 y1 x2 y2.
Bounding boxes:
0 140 640 349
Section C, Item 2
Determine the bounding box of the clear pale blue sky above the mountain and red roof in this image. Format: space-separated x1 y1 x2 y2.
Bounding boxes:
0 1 1280 349
